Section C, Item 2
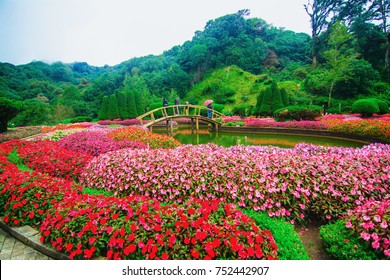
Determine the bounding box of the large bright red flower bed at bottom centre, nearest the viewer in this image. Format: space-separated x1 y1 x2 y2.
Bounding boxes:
40 195 277 259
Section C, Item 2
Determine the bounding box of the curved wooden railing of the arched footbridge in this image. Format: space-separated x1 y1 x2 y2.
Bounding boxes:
137 104 223 125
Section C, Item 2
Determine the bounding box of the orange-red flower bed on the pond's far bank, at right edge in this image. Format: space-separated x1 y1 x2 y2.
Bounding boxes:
325 120 390 141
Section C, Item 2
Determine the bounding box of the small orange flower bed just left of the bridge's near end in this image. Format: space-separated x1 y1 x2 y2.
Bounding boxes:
108 127 181 149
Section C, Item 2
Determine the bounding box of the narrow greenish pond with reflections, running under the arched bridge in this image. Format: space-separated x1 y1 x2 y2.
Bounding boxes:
153 127 369 148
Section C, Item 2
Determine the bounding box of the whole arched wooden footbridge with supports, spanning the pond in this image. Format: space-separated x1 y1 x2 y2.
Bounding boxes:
137 105 223 131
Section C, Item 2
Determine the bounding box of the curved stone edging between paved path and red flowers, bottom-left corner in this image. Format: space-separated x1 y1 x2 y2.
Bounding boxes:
0 219 70 260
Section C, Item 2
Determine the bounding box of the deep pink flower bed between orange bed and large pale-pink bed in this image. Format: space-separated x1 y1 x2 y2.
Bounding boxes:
58 131 147 156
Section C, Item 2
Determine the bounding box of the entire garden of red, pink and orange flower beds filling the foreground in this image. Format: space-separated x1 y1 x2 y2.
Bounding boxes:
0 119 390 260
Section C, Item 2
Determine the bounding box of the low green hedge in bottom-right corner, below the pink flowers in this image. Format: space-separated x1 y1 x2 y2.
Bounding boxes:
320 220 386 260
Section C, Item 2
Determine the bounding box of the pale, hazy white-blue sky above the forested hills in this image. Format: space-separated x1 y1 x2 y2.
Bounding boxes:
0 0 310 66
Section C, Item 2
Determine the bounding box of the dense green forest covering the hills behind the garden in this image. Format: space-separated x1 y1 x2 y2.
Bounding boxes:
0 0 390 126
